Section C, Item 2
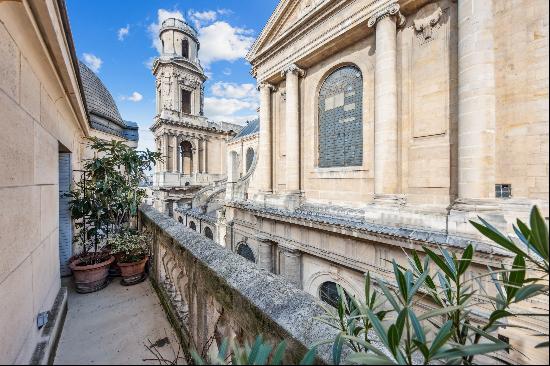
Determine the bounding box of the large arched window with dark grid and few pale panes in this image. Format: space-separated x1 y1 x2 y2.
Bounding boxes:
319 66 363 168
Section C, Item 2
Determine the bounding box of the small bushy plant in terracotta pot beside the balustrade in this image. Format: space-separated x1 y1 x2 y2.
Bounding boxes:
109 231 150 285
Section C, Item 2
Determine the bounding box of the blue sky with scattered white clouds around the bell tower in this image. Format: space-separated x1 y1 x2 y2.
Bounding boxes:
67 0 278 149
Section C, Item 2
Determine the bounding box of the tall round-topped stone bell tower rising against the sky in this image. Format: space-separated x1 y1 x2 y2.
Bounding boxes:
151 18 245 216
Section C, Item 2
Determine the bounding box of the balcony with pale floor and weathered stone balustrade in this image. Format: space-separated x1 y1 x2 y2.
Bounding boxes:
51 205 335 364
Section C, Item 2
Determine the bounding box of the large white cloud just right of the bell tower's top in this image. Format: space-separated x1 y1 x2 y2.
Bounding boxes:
199 21 254 67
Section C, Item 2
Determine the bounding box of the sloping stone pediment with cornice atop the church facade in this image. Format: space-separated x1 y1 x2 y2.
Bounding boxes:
247 0 416 82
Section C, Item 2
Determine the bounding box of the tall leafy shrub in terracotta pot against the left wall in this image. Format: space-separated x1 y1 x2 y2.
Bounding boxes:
68 138 160 293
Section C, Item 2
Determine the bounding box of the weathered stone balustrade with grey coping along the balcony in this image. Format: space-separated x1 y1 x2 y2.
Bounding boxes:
139 205 336 364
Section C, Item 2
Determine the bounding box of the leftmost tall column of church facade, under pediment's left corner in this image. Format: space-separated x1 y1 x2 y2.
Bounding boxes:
257 83 275 192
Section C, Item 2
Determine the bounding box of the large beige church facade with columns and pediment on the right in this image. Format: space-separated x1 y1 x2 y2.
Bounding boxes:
223 0 549 362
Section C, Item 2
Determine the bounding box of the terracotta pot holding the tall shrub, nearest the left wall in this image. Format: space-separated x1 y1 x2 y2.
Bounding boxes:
69 256 115 294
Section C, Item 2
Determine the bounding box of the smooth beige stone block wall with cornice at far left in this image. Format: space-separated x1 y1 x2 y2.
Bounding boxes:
0 0 88 364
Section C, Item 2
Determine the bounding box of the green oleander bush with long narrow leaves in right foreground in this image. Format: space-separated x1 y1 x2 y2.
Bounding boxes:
319 207 549 365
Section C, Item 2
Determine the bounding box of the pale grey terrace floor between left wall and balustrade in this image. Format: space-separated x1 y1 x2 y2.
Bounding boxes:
54 278 184 365
